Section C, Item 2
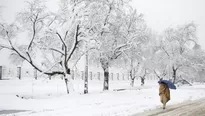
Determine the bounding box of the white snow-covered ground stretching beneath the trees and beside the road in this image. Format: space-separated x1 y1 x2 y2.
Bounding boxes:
0 79 205 116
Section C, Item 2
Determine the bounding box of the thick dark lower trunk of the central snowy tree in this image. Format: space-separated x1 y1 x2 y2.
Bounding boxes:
103 65 109 91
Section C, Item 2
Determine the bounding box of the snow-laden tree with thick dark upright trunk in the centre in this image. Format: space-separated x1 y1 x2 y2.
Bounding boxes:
89 0 147 90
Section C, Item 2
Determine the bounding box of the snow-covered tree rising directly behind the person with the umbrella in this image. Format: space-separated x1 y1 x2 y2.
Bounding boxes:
161 23 198 83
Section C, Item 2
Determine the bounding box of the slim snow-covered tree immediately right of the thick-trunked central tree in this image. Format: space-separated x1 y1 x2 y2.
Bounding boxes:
121 25 152 86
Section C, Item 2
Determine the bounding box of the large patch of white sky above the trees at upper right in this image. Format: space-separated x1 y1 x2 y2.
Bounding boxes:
133 0 205 42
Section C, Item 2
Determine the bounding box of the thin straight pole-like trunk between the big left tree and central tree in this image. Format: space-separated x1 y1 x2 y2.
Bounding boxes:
84 43 88 94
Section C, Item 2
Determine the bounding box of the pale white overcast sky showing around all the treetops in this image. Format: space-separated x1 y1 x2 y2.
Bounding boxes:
0 0 205 65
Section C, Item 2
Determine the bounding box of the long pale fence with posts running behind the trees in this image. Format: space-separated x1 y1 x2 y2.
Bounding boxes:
0 66 158 81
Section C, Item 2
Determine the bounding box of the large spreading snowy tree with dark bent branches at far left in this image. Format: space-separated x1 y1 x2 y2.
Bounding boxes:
1 0 96 93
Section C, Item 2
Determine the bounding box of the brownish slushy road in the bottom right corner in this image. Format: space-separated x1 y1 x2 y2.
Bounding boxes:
132 99 205 116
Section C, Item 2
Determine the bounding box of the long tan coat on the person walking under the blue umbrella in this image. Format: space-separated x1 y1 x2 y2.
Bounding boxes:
159 83 170 109
